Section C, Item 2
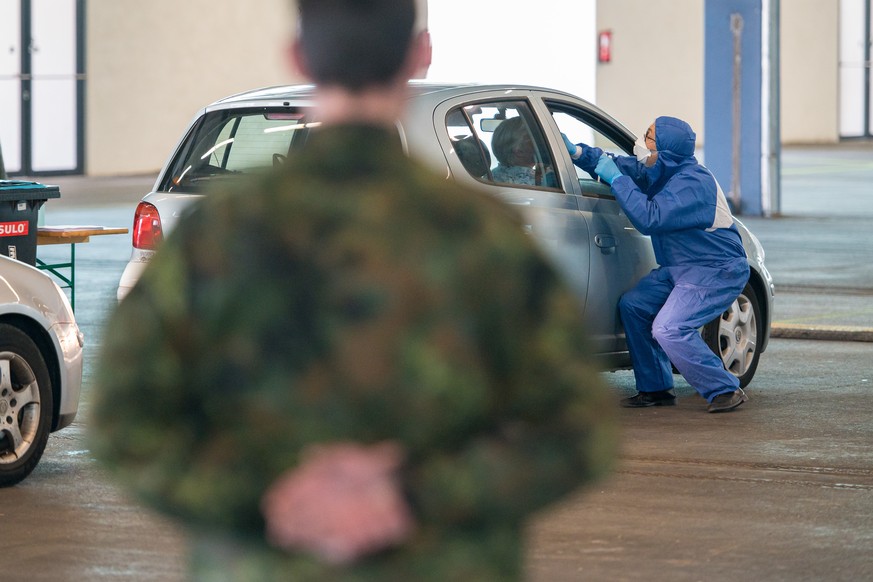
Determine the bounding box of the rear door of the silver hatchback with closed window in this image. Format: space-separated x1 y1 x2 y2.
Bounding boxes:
434 90 615 352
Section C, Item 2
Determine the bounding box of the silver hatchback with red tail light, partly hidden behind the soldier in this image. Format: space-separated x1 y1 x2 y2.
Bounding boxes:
118 83 773 386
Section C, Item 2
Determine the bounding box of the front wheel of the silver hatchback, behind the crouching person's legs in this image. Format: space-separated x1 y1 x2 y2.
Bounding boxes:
701 283 764 388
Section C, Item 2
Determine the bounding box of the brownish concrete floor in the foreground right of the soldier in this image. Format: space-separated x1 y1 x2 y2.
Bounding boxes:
531 340 873 582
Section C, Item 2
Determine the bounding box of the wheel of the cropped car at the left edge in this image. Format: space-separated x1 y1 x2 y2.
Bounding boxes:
0 323 52 487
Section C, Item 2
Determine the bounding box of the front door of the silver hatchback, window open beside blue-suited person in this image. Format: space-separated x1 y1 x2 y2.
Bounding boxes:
535 92 656 353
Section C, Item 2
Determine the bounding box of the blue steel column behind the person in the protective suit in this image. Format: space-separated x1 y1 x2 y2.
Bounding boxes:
704 0 780 216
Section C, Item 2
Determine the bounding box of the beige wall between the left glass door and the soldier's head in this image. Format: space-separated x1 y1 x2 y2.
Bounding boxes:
86 0 293 175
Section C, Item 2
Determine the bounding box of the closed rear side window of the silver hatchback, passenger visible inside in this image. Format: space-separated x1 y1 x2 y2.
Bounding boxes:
446 101 559 190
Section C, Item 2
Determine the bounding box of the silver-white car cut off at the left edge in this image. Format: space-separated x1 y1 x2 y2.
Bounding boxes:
0 256 85 487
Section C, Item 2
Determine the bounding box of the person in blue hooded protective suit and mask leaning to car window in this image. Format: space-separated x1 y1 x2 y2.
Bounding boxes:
567 117 749 412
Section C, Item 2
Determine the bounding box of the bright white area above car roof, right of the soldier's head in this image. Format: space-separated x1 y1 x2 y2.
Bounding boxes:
427 0 597 100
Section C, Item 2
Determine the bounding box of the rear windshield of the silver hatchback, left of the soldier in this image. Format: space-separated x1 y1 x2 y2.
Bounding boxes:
160 108 316 192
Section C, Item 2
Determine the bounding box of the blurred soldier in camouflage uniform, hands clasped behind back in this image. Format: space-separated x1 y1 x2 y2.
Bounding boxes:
91 0 615 581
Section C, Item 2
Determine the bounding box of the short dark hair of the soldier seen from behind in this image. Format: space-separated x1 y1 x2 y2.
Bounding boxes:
297 0 415 91
